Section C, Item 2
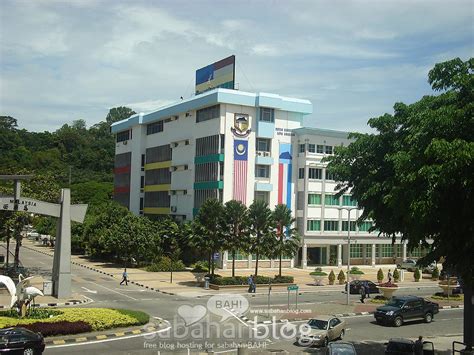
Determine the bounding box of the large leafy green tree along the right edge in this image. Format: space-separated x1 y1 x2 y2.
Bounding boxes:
328 58 474 349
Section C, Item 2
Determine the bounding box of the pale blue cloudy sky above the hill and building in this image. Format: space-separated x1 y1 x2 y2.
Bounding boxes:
0 0 474 132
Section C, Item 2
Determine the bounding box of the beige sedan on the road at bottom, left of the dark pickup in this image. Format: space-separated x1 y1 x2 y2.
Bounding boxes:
296 316 346 346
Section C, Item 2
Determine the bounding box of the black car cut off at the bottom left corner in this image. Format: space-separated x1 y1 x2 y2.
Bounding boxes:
0 327 44 355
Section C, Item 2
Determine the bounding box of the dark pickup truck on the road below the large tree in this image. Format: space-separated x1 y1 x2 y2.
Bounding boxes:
374 296 439 327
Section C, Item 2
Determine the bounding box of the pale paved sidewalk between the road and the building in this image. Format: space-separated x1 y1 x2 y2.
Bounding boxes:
23 239 436 298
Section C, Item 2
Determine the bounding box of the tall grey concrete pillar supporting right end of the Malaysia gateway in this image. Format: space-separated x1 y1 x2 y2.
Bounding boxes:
53 189 71 298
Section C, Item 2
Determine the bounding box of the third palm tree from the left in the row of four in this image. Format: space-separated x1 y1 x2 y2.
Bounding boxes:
249 200 275 276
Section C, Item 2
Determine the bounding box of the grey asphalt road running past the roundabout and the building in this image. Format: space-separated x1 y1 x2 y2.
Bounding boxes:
3 248 462 354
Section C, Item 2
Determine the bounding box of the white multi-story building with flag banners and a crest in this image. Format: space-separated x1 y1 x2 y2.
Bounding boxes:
112 88 426 268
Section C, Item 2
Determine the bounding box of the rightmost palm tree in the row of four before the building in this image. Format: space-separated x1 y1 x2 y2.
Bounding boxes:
273 204 300 277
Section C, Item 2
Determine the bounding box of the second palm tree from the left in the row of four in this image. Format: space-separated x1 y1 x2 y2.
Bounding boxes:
222 200 250 277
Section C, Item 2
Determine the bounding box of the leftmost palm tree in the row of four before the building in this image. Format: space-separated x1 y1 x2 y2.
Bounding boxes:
193 198 224 276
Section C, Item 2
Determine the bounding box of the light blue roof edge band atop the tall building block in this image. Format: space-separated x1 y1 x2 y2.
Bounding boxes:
111 88 313 133
